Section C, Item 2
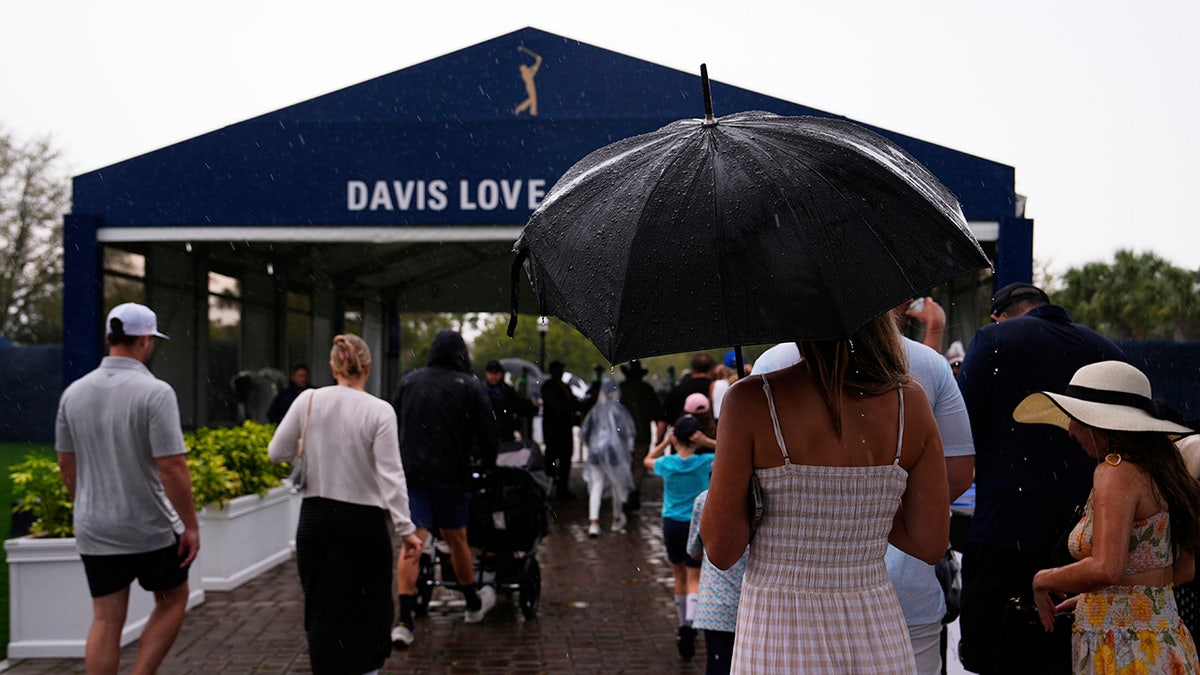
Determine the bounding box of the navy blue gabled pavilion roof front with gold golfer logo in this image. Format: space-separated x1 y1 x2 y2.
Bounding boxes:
73 28 1015 228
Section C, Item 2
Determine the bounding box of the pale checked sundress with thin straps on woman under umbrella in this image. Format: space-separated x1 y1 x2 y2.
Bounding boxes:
732 378 916 675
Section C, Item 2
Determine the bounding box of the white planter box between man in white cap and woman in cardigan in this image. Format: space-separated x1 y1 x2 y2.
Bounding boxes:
199 485 300 591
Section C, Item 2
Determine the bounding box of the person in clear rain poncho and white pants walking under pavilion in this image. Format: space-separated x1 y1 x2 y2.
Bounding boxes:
580 377 636 537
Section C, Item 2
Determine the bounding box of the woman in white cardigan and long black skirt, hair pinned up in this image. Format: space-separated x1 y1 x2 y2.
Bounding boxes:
269 335 420 675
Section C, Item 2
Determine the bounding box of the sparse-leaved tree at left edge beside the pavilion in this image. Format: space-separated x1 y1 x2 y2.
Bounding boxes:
0 127 70 344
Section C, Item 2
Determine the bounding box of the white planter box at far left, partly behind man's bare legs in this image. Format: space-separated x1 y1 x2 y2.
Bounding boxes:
4 537 204 658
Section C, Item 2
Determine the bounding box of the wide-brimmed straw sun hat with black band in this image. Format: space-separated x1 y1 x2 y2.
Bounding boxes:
1013 362 1196 440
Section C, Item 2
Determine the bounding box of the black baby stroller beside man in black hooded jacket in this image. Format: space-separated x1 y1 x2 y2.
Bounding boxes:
416 441 550 620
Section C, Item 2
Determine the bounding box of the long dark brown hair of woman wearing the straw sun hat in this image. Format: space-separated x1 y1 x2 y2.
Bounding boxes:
1090 428 1200 555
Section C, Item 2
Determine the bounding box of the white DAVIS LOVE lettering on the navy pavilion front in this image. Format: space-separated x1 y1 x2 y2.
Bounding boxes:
346 178 546 211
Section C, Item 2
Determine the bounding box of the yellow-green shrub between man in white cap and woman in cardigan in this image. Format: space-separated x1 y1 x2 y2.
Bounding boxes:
184 420 290 506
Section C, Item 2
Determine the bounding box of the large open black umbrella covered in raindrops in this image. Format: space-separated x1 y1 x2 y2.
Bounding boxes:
509 66 990 363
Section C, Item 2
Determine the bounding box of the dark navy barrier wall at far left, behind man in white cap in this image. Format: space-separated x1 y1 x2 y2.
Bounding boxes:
0 345 62 442
